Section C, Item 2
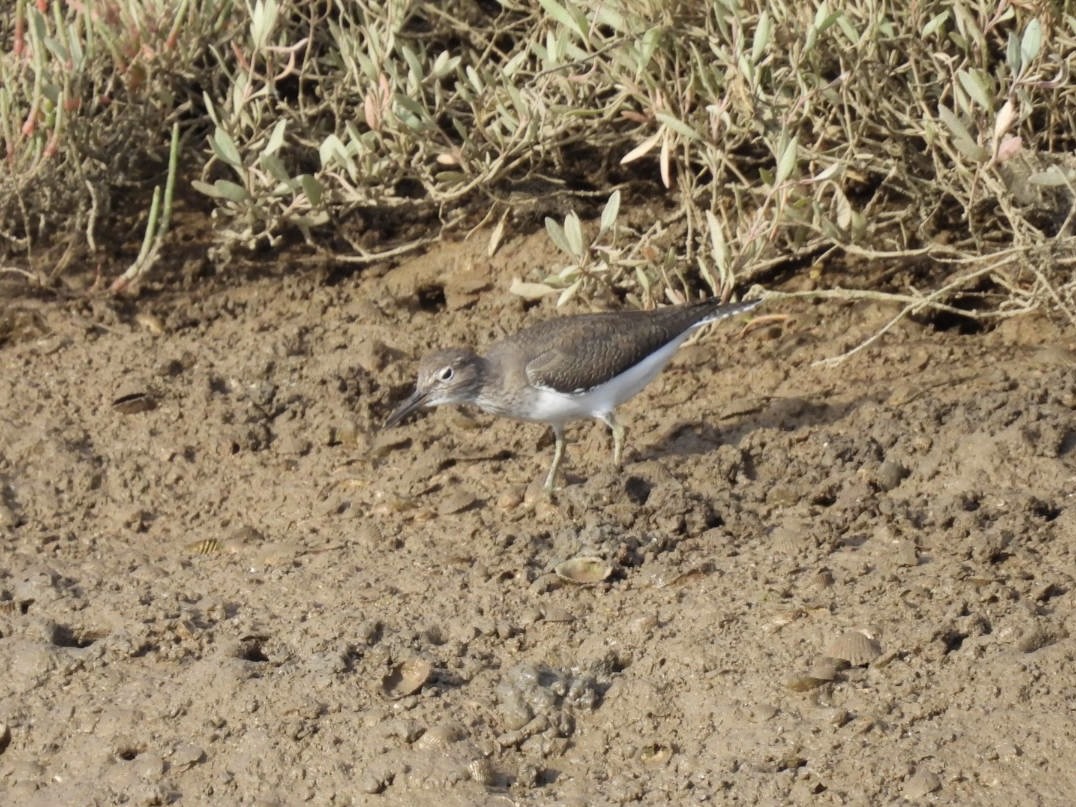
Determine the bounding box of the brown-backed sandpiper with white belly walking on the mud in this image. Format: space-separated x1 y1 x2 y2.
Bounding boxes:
384 298 762 492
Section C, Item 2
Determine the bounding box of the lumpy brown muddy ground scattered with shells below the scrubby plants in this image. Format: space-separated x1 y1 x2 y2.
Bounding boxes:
0 233 1076 807
